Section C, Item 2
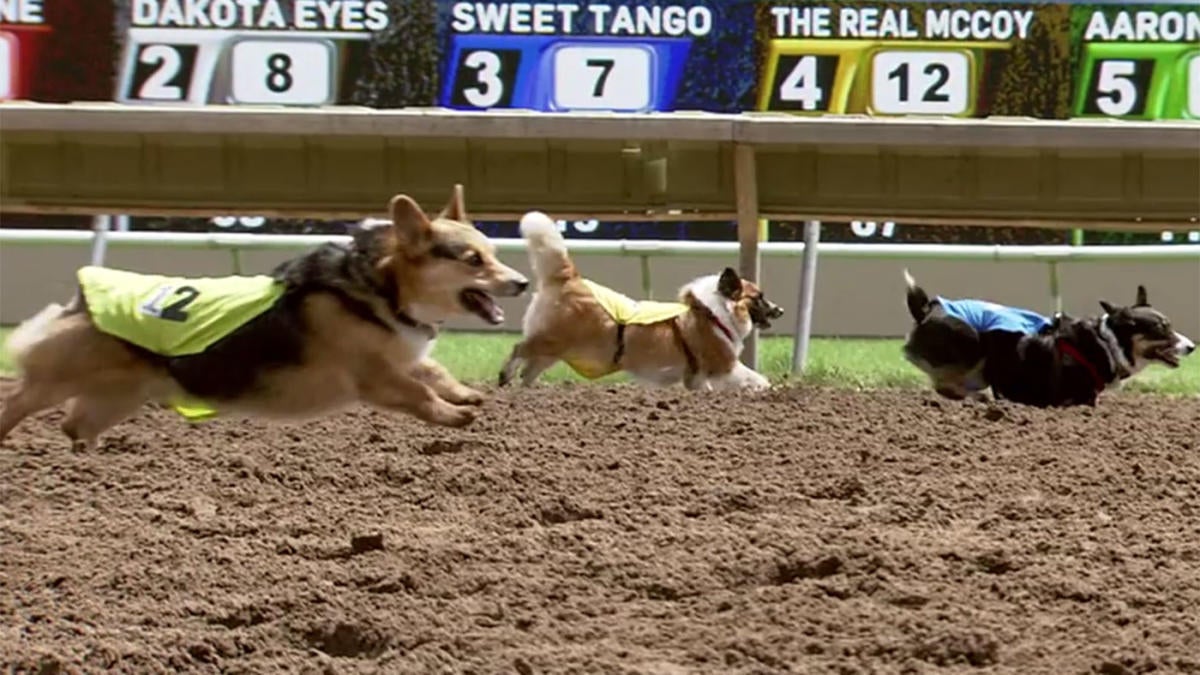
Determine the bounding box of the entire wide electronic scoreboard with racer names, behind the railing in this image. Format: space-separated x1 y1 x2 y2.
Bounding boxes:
0 0 1200 240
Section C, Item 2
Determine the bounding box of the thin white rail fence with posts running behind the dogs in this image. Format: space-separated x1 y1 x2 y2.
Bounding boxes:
0 229 1200 372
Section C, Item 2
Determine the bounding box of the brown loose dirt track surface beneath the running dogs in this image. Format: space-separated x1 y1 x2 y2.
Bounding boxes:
0 386 1200 674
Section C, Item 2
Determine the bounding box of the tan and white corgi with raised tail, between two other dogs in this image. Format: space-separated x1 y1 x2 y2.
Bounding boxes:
499 211 784 389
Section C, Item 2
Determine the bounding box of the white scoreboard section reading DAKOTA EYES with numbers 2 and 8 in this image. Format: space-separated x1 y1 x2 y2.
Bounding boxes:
114 0 390 106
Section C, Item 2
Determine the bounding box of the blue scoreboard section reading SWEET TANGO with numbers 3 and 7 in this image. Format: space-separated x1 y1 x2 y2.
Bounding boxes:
438 1 752 113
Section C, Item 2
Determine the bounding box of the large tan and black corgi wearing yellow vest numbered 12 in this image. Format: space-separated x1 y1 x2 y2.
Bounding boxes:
0 186 528 450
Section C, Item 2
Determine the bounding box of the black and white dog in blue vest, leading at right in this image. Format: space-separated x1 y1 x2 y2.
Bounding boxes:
904 270 1195 407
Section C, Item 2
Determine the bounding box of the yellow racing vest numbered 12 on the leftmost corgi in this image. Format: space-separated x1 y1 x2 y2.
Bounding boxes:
77 265 283 422
